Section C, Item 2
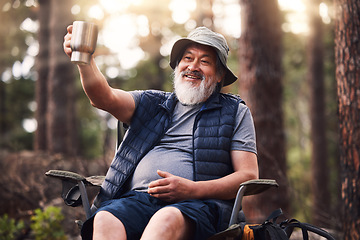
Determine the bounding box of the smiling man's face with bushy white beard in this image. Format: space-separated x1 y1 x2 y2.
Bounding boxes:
174 44 222 105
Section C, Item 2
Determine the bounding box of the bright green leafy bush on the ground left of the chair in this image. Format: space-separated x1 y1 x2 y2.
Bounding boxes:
30 206 67 240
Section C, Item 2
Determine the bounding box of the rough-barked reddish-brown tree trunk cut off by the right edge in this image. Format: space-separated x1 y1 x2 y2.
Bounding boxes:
335 0 360 240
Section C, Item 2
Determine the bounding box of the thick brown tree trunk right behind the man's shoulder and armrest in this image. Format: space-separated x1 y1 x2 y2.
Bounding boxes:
239 0 289 222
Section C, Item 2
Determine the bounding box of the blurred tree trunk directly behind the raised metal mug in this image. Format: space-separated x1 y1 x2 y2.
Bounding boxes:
47 0 78 155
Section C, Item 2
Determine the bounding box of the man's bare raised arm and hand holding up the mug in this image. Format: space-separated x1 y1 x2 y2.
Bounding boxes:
63 25 135 124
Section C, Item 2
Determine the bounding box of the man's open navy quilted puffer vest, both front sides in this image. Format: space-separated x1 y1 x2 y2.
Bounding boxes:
96 91 244 205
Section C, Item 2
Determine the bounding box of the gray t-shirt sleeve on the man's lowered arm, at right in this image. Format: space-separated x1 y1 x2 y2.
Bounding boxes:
231 103 257 154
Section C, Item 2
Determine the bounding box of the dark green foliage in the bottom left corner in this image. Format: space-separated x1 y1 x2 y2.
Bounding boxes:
0 214 25 240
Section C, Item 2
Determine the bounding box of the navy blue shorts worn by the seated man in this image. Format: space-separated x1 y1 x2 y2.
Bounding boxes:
81 191 223 240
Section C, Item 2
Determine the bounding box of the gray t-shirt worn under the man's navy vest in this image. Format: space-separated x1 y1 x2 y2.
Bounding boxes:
130 91 256 191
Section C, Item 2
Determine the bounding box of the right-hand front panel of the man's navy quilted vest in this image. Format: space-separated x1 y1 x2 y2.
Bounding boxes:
193 94 243 181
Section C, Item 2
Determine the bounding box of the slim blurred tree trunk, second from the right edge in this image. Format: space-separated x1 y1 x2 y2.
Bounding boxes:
307 0 331 227
